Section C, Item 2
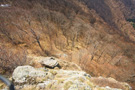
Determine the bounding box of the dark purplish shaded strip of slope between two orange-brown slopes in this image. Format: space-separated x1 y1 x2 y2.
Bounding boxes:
82 0 117 28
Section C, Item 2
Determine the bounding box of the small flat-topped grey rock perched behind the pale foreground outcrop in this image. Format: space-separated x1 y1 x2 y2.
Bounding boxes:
39 57 59 68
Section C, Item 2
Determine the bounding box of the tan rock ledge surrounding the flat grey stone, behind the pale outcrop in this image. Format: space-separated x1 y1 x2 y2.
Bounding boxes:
28 55 82 71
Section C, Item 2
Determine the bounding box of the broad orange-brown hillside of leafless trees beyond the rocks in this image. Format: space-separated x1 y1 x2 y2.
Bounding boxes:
0 0 135 89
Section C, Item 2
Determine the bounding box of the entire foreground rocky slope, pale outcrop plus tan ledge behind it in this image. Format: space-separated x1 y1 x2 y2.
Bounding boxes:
2 57 131 90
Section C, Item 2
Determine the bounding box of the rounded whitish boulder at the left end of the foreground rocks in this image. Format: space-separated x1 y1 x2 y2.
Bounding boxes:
12 66 47 84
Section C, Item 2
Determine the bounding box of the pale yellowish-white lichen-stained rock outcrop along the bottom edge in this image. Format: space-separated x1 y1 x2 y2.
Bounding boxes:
12 66 131 90
